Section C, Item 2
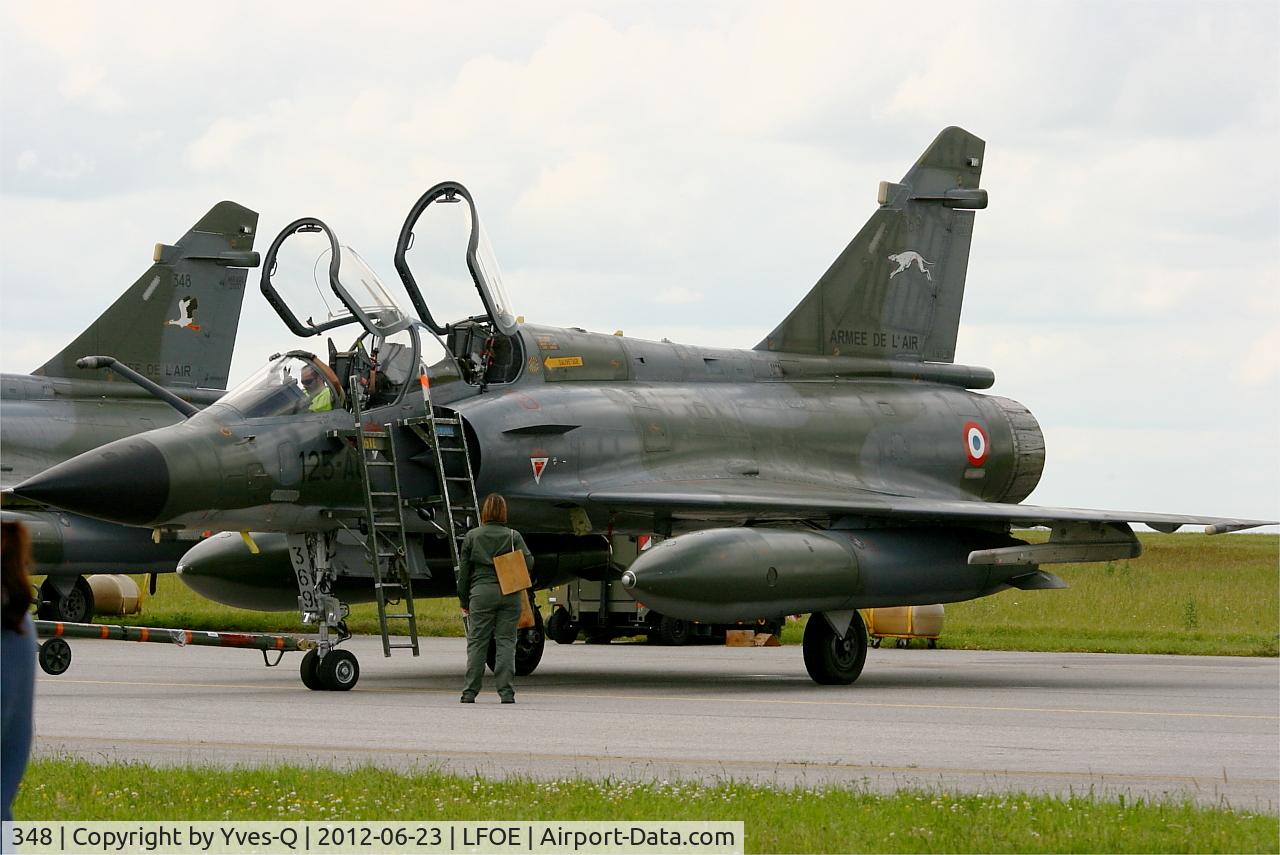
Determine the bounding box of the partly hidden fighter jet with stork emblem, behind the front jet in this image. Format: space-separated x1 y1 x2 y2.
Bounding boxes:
0 202 259 622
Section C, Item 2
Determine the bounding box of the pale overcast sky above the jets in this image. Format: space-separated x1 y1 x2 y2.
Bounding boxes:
0 0 1280 518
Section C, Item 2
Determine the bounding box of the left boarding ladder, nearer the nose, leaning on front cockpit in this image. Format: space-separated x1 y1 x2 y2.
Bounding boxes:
347 378 419 657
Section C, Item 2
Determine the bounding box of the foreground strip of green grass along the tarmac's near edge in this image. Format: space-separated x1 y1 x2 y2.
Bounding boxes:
14 759 1280 852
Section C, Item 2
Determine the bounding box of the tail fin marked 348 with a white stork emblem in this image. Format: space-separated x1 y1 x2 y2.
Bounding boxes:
32 202 259 389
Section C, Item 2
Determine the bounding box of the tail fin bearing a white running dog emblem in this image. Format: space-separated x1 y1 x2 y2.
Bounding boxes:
755 127 987 362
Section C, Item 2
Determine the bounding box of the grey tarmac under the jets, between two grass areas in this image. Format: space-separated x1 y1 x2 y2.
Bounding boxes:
36 637 1280 813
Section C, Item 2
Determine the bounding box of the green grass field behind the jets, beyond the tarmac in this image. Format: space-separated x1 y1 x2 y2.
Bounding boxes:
64 531 1280 657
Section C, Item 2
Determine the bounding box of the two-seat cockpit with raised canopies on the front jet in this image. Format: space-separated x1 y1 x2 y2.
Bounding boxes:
252 182 525 416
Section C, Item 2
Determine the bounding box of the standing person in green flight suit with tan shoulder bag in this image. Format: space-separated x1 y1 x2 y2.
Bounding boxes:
458 493 534 704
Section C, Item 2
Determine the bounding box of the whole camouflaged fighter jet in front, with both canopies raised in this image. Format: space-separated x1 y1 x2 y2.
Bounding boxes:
18 128 1260 689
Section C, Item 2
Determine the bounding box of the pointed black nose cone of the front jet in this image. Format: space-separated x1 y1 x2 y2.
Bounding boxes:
13 438 169 526
